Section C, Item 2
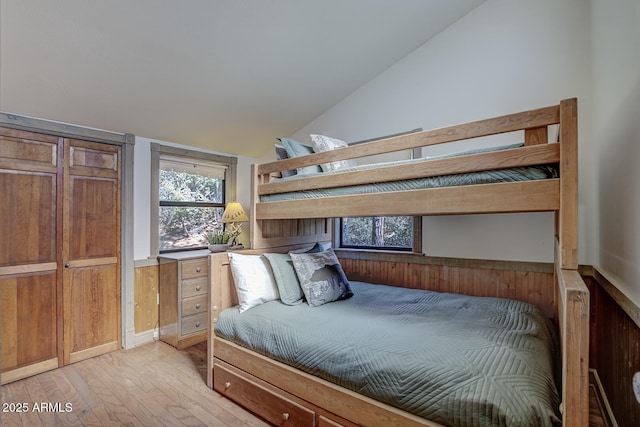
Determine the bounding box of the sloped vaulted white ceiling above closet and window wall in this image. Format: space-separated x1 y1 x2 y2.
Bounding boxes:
0 0 483 157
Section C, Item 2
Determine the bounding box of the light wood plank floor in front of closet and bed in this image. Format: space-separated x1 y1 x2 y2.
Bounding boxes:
0 342 267 427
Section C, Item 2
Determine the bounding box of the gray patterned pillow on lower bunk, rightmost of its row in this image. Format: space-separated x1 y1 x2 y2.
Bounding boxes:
290 248 353 307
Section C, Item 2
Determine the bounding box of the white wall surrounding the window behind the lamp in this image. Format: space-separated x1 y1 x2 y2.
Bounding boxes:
133 136 256 261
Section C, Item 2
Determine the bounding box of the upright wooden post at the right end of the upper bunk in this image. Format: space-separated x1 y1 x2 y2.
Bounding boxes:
556 98 578 270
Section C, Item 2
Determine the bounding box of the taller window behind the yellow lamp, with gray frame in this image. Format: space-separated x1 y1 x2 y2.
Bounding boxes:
151 144 237 253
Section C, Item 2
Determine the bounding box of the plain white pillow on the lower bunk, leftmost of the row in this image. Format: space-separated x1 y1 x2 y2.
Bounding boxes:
229 252 280 313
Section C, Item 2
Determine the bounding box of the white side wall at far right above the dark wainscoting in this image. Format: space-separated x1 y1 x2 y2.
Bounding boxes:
591 0 640 306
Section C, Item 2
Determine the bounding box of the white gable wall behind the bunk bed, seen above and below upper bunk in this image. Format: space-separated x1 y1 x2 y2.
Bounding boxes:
292 0 594 263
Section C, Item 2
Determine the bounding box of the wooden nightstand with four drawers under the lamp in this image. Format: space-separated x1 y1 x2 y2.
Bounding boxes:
158 250 210 350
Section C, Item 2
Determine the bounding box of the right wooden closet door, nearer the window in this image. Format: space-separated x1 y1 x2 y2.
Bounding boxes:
62 139 121 364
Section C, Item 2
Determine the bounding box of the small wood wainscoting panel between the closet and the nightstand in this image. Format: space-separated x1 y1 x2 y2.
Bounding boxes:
133 265 159 334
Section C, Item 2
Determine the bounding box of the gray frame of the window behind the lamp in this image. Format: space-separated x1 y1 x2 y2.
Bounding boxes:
149 143 238 257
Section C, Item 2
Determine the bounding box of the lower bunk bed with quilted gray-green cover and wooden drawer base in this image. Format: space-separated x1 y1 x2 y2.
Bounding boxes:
208 249 584 426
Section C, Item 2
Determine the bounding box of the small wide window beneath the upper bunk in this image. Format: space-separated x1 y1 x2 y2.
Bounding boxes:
339 216 420 251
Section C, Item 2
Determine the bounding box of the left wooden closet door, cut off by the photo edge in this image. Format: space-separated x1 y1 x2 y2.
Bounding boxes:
0 128 62 384
